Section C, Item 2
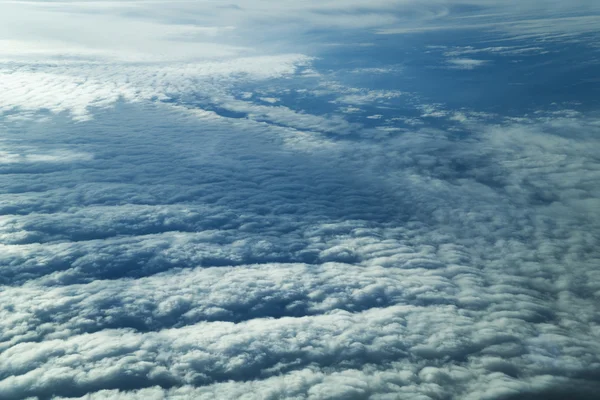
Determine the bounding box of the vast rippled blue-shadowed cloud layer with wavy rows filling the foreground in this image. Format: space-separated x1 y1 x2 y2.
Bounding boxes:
0 97 600 398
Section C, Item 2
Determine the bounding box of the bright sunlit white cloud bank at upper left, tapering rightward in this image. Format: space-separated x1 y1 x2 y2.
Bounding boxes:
0 54 310 120
